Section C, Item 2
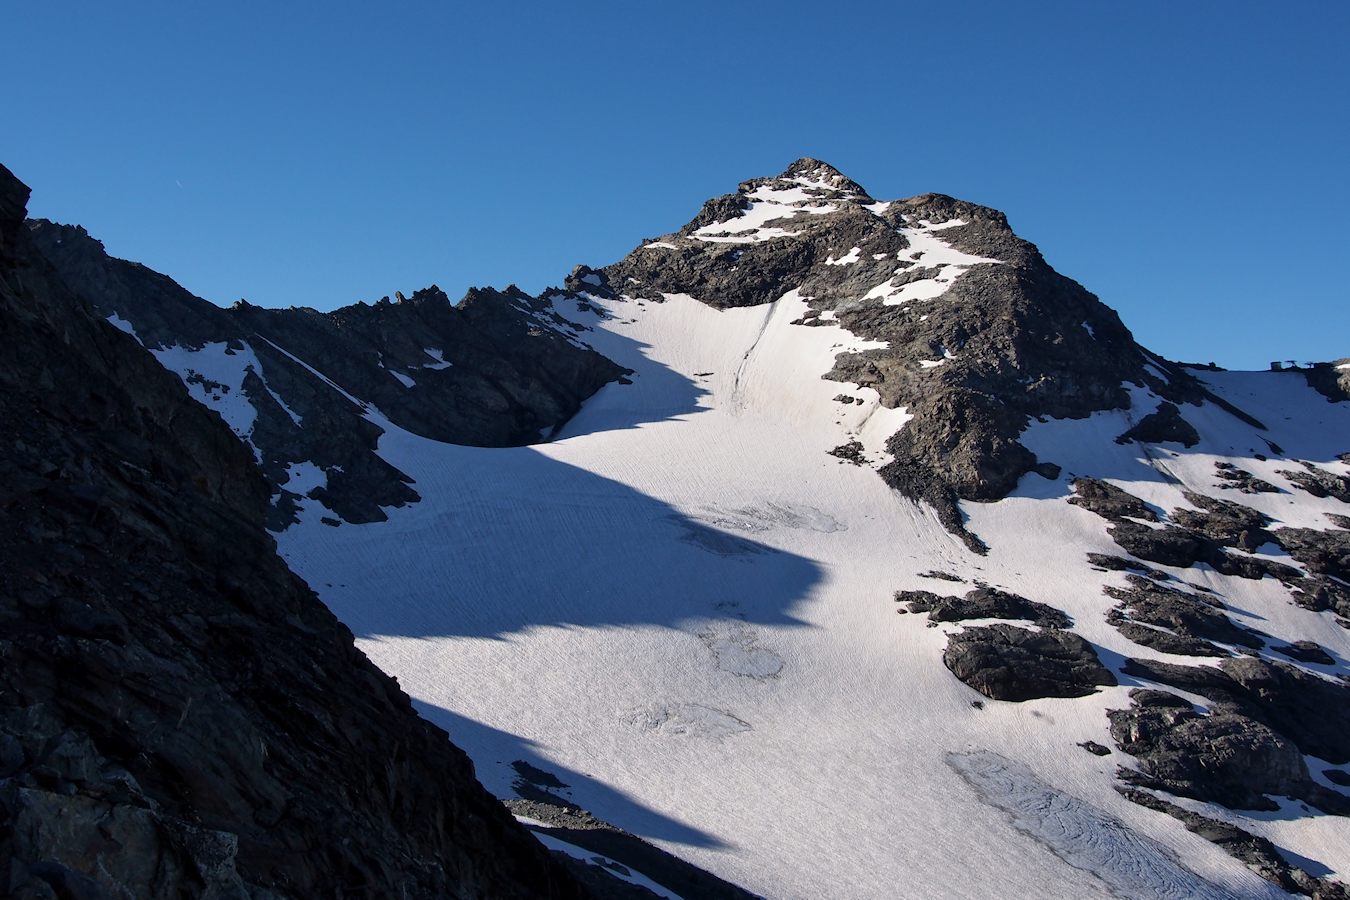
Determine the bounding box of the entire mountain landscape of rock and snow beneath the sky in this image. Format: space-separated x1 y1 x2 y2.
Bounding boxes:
0 158 1350 897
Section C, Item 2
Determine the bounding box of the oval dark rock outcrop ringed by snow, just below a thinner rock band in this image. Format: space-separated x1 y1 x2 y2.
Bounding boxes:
942 625 1115 700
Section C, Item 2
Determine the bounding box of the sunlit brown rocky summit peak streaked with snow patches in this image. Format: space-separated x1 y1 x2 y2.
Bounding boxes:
601 159 1236 552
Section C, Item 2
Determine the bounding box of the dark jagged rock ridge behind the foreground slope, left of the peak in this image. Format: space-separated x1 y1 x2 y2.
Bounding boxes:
30 220 625 529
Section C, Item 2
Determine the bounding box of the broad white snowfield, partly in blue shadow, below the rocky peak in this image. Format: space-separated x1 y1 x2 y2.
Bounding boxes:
263 284 1350 897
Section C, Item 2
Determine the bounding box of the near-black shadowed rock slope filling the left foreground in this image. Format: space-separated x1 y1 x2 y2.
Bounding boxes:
0 167 582 897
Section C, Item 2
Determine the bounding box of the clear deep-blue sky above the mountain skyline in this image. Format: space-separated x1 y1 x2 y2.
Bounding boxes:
10 0 1350 368
